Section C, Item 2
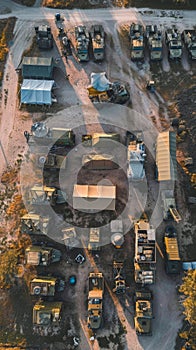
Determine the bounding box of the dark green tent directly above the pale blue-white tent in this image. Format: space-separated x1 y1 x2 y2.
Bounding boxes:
22 57 54 80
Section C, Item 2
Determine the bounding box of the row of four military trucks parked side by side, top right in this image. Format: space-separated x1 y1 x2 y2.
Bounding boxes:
129 23 196 61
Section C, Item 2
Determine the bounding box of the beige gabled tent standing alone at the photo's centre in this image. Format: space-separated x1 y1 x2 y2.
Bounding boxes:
73 185 116 211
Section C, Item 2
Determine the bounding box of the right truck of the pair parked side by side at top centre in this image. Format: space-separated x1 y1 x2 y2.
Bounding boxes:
90 24 105 61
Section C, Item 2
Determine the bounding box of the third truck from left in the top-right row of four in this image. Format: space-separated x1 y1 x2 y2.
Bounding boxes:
165 27 182 60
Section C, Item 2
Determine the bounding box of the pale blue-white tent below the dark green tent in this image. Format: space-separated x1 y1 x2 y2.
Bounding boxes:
21 79 54 105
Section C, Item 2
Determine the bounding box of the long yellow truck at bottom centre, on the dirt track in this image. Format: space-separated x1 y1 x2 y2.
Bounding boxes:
87 272 104 330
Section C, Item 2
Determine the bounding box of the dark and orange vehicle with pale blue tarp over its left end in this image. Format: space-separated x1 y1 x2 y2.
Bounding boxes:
87 72 130 104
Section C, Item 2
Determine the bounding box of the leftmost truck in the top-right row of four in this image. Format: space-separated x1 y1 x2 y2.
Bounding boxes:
129 23 144 61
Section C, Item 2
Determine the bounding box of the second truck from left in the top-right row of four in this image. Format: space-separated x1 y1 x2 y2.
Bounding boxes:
145 25 163 61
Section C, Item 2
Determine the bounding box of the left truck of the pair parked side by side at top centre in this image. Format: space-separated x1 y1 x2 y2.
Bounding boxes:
75 25 90 62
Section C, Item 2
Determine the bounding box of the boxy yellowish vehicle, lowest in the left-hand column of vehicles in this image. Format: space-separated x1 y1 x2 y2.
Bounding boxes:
33 301 63 330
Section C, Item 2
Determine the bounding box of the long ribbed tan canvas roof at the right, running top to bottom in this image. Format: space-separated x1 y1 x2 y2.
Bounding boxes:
156 131 177 181
